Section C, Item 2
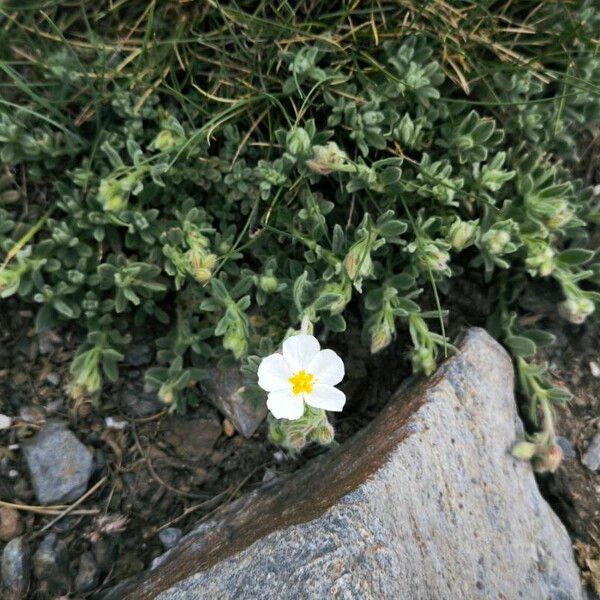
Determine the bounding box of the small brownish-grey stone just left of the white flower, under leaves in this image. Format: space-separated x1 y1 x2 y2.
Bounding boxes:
202 368 267 438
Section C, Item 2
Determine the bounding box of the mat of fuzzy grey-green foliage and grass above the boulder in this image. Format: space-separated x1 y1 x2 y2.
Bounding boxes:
0 1 600 596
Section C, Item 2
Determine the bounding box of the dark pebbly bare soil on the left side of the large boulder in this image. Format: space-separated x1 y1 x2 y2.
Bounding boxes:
0 309 409 598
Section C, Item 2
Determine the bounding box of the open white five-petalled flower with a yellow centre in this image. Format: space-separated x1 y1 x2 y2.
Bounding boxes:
258 334 346 420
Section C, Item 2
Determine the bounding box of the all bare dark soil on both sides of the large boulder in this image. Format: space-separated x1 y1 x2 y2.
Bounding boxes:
0 298 600 598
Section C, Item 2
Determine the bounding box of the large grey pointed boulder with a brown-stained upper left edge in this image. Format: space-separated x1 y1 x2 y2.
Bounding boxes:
108 329 582 600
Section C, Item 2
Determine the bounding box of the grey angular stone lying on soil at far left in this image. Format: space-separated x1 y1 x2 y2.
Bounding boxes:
23 421 92 504
